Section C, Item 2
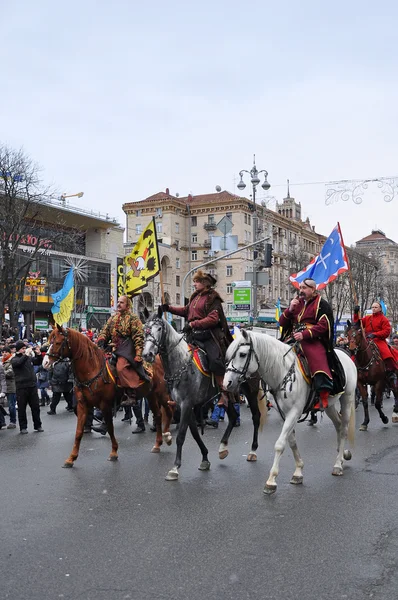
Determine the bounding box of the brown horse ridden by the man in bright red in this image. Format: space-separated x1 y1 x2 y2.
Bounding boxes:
346 321 397 431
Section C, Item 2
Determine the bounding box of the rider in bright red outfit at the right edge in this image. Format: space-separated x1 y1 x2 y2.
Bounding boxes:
354 300 398 375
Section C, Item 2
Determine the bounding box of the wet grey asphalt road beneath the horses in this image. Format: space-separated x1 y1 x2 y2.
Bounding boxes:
0 401 398 600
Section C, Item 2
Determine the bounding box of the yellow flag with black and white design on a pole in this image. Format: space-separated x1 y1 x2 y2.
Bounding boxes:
124 218 160 296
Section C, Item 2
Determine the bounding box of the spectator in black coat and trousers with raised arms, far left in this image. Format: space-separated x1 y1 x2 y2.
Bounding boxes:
11 340 43 433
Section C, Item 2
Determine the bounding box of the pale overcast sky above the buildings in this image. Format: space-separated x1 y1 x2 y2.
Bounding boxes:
0 0 398 244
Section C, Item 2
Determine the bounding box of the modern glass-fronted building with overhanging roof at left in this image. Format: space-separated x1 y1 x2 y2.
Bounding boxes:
18 199 124 330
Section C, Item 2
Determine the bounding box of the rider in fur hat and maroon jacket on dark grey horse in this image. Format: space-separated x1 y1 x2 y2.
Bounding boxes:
162 269 232 406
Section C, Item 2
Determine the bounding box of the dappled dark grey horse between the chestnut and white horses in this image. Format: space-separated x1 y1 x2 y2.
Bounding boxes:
142 308 267 481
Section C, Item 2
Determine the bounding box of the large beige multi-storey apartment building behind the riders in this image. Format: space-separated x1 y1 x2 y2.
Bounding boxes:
123 189 326 320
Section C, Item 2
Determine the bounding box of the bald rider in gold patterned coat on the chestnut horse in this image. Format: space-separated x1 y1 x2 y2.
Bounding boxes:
97 296 150 406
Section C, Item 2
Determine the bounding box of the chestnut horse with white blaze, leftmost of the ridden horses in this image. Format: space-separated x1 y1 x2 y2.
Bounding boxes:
43 326 173 467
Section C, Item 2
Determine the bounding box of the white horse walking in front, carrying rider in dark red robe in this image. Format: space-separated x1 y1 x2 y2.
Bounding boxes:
224 330 357 494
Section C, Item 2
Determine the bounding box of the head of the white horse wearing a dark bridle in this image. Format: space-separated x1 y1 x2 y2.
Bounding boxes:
224 329 259 391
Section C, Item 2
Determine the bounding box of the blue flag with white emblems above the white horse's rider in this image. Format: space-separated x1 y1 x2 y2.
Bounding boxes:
289 224 350 290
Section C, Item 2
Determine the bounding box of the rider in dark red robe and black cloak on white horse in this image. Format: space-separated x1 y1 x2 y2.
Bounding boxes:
279 278 342 409
